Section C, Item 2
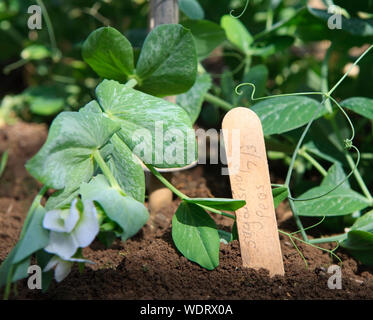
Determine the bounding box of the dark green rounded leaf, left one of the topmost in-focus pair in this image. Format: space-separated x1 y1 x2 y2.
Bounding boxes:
82 27 134 81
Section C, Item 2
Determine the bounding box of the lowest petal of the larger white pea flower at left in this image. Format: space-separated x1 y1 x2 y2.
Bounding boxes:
44 231 79 260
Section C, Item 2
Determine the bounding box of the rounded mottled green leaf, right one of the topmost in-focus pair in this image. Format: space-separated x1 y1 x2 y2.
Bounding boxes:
136 24 197 96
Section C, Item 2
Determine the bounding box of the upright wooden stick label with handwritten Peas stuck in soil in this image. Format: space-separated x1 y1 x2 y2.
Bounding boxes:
222 107 284 276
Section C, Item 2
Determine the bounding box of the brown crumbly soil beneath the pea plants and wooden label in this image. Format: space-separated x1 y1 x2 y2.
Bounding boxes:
0 122 373 300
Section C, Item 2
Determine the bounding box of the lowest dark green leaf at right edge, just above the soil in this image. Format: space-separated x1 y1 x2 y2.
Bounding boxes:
341 230 373 265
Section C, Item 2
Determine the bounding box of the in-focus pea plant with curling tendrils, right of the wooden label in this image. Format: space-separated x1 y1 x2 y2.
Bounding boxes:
236 45 373 265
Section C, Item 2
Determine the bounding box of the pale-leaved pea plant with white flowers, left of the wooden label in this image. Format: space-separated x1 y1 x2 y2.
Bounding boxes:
0 25 245 298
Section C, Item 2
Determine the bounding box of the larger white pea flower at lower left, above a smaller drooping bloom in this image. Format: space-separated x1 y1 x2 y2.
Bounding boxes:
43 199 99 260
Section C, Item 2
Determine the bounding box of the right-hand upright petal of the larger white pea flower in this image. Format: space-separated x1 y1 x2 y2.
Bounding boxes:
71 201 100 248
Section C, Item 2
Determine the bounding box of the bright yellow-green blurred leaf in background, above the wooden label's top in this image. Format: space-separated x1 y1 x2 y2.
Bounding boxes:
220 15 254 53
